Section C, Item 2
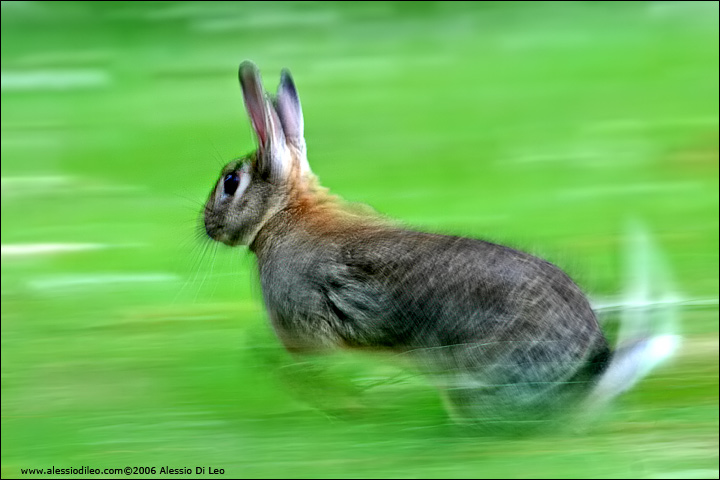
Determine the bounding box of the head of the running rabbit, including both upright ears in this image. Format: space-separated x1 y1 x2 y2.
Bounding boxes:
204 61 312 245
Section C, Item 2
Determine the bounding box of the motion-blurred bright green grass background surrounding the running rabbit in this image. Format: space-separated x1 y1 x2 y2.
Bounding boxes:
1 2 718 478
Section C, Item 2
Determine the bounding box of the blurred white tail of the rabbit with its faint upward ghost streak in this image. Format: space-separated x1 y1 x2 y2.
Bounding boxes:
586 223 680 412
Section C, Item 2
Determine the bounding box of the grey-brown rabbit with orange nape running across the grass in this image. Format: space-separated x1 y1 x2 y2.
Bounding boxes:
204 61 680 428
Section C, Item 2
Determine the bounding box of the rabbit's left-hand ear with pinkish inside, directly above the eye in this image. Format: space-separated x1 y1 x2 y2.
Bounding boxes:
239 61 288 180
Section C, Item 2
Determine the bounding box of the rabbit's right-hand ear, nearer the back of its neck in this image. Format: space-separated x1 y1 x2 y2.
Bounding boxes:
274 68 310 176
